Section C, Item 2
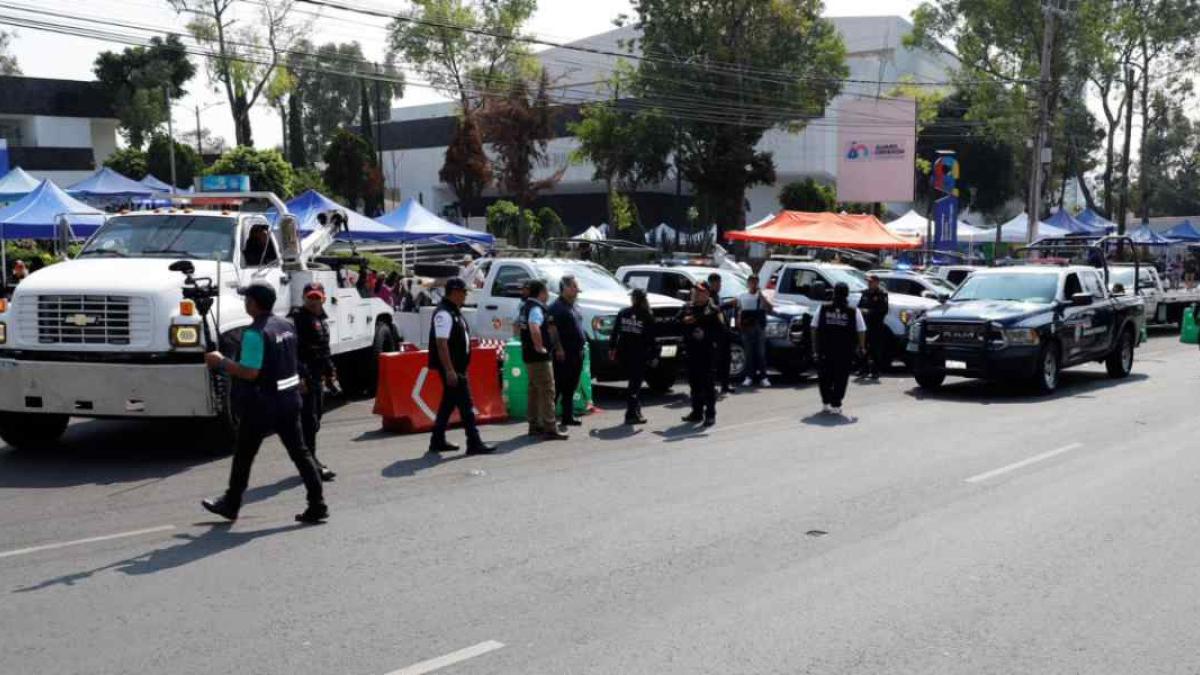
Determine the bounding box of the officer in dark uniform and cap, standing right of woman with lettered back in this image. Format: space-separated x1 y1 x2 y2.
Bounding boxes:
679 281 725 426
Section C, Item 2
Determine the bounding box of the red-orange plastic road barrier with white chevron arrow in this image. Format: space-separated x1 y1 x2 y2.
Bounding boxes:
374 340 508 434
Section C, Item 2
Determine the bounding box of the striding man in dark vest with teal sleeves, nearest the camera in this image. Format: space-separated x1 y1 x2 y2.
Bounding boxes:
202 283 329 524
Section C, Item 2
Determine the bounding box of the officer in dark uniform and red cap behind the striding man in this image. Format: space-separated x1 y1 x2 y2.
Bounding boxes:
292 281 337 483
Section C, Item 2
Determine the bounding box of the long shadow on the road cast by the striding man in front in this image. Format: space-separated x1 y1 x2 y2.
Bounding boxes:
13 522 302 593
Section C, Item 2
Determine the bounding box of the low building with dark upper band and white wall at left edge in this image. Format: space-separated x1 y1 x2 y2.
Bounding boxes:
0 76 116 187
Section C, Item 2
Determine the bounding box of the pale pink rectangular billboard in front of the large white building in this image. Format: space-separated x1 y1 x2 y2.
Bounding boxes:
838 100 917 202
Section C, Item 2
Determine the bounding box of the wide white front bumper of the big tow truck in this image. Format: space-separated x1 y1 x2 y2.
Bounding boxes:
0 358 217 417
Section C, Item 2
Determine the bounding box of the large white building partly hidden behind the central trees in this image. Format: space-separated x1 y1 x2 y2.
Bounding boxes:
382 17 955 232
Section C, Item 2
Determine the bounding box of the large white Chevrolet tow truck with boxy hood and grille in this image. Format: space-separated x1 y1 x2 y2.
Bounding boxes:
0 192 396 450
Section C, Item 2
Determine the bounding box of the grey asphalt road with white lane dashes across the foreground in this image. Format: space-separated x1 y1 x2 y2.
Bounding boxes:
0 335 1200 675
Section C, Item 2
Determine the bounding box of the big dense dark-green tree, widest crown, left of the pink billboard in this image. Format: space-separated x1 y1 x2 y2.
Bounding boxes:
632 0 847 229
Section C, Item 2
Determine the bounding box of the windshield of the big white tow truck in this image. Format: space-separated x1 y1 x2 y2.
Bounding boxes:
79 214 238 262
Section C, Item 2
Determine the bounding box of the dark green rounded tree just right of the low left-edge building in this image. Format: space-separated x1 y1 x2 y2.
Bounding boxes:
92 35 196 149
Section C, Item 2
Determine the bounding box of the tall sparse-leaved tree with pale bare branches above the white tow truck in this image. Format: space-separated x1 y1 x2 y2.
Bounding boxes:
168 0 306 147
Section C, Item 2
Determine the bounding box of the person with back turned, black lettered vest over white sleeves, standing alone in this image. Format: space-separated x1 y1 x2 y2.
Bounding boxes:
812 282 866 414
